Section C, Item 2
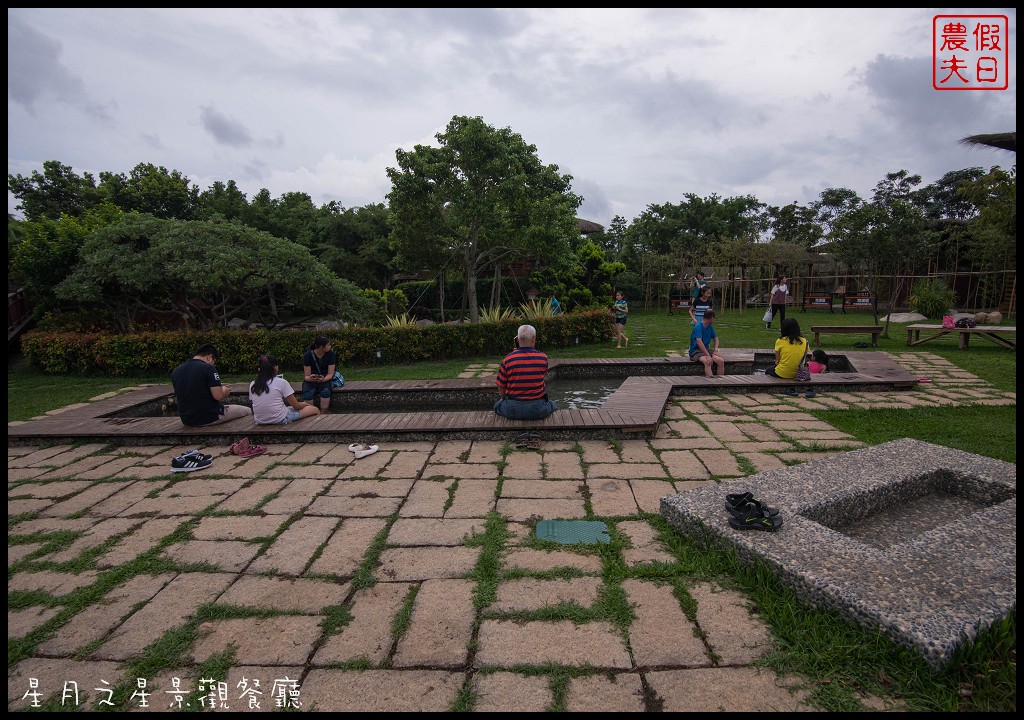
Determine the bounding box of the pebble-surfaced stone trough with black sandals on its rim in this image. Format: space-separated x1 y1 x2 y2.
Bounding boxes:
662 438 1017 669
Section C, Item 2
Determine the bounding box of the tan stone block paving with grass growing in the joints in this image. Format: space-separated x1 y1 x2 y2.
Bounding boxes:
7 353 1016 712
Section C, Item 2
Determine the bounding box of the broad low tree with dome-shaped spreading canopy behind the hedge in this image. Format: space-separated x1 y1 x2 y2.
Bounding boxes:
56 215 374 330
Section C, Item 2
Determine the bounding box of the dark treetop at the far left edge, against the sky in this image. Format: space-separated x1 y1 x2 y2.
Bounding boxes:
7 160 102 221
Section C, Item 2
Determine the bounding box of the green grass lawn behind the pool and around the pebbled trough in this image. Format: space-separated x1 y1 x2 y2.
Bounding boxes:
7 309 1017 712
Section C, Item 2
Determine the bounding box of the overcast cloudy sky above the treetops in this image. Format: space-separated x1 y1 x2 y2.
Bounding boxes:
7 8 1017 225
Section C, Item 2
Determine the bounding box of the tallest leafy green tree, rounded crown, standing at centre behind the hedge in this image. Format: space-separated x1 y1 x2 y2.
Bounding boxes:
387 116 582 322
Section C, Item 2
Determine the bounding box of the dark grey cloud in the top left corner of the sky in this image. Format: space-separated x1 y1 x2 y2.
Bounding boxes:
7 12 110 120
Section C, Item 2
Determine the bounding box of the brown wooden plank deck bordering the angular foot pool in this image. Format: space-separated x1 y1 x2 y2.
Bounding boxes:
7 350 918 446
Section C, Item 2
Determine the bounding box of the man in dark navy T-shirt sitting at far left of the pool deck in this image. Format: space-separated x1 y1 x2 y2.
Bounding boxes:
171 343 252 427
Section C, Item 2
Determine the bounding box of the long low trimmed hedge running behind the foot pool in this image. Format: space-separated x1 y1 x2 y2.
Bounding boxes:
22 309 613 377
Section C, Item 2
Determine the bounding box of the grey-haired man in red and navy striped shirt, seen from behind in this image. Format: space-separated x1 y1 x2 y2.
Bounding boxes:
495 325 555 420
